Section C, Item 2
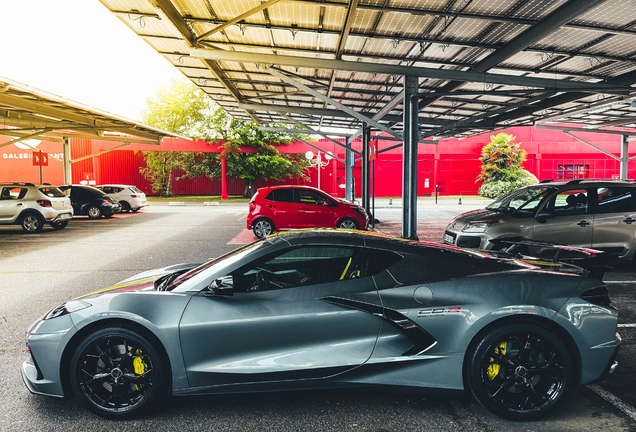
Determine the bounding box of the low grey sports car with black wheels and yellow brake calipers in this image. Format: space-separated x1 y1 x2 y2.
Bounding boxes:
22 230 620 420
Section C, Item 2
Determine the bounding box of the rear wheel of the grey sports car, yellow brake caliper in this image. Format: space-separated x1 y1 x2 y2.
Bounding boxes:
466 320 574 421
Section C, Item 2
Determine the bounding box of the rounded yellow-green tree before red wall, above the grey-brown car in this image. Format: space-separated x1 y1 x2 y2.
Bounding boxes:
476 133 538 198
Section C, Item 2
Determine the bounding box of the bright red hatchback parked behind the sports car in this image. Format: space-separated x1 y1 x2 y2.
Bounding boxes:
247 186 369 238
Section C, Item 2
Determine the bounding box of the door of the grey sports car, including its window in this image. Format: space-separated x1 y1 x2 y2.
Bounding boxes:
180 246 381 387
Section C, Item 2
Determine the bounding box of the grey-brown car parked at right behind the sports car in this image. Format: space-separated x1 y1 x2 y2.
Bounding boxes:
444 180 636 260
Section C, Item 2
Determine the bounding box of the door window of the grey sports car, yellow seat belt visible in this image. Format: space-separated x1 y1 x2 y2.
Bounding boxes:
232 246 365 292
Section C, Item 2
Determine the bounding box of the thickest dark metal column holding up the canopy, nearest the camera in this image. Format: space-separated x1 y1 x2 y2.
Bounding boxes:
402 75 419 240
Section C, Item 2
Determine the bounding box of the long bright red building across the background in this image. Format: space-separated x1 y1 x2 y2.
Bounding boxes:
0 127 636 196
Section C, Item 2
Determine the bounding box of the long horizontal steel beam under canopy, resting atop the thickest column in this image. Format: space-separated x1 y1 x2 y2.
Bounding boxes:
190 48 630 96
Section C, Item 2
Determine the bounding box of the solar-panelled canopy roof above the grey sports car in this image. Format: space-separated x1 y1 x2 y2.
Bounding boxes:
100 0 636 137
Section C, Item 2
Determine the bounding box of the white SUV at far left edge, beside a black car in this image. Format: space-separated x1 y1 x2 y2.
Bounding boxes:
0 183 73 233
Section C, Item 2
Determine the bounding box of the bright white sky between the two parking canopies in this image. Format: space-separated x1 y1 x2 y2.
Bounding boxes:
0 0 175 120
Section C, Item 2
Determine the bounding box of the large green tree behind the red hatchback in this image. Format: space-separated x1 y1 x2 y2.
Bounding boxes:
186 108 309 197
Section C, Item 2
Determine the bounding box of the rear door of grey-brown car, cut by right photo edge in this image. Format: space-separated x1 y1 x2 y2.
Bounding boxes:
590 186 636 255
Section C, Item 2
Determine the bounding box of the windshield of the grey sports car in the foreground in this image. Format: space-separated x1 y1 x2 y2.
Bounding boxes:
167 239 270 291
